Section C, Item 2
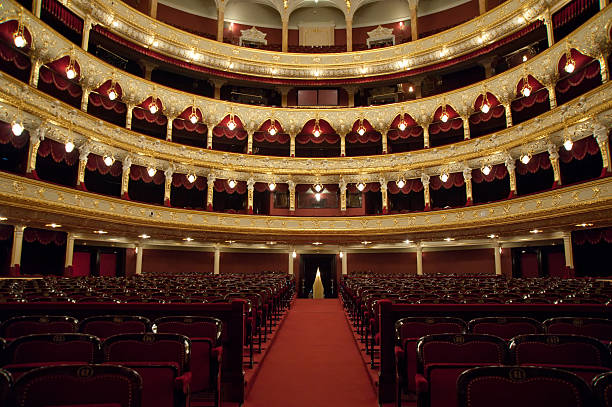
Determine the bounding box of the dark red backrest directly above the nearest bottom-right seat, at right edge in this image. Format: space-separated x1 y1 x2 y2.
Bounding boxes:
509 334 611 366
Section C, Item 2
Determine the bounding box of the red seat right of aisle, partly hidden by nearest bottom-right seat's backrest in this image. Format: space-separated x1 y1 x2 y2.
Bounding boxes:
415 334 506 407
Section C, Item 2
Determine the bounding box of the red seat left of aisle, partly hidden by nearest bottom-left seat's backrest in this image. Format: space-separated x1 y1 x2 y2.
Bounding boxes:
102 333 191 407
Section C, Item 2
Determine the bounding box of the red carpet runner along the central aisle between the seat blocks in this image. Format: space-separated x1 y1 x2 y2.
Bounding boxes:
245 299 377 407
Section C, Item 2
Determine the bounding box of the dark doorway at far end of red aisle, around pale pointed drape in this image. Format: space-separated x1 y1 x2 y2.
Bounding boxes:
298 254 338 298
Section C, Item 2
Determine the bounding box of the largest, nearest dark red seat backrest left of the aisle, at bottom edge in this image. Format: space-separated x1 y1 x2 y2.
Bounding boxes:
13 365 142 407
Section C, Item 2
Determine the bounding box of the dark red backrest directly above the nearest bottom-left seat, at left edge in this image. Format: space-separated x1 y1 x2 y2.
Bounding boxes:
4 333 101 364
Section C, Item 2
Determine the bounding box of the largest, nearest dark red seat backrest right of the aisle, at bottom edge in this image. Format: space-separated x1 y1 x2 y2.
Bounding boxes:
457 366 592 407
